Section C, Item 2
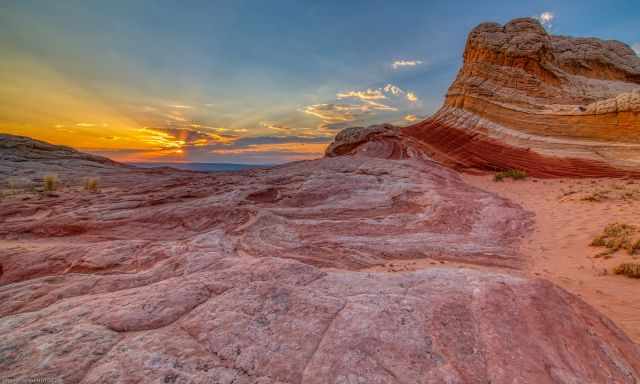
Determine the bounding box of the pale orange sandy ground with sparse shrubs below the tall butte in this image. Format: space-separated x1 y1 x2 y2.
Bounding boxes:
365 175 640 343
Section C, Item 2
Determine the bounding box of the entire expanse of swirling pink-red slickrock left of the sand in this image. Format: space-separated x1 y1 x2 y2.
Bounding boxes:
0 134 640 384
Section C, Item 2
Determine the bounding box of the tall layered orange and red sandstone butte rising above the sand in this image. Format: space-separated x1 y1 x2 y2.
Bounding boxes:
336 19 640 176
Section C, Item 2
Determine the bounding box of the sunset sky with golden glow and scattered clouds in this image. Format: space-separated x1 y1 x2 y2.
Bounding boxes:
0 0 640 164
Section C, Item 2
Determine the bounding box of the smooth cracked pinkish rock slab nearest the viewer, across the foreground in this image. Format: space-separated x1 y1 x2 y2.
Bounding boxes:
0 258 640 384
